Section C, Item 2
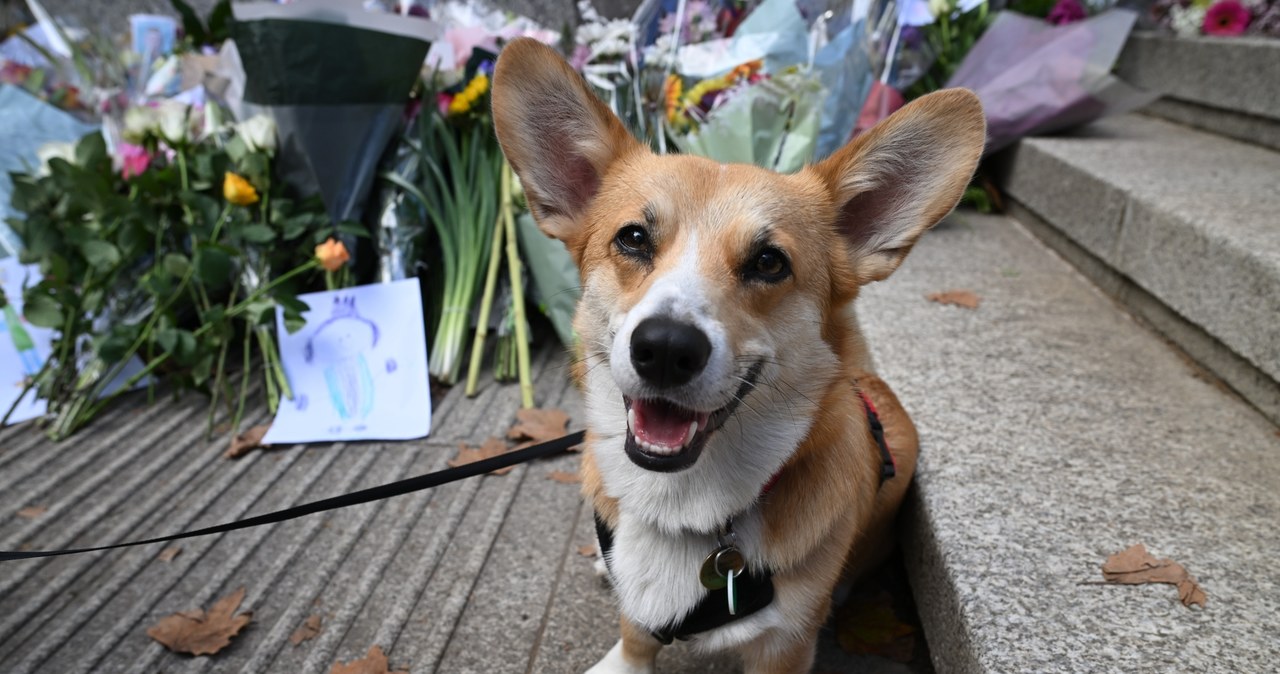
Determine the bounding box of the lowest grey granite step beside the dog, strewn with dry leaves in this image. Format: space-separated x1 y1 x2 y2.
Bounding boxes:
859 211 1280 673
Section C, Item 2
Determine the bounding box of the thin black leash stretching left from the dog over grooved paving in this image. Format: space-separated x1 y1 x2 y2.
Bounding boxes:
0 431 586 561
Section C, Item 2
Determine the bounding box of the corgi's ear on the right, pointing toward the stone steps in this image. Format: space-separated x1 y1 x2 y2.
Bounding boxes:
812 90 987 284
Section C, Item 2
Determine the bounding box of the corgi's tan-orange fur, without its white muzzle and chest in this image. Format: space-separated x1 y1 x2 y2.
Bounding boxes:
493 41 984 674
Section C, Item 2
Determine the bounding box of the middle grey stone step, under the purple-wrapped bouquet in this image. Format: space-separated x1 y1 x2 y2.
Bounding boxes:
993 115 1280 421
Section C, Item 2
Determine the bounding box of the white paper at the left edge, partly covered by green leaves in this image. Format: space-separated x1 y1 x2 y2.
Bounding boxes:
0 257 54 423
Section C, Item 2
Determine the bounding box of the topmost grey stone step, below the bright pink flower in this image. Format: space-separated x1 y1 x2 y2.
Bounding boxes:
1116 33 1280 150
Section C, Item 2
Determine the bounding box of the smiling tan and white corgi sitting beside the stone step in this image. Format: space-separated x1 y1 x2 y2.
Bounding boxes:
493 40 986 674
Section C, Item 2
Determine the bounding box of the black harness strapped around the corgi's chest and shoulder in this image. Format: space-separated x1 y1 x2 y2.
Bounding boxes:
595 394 897 645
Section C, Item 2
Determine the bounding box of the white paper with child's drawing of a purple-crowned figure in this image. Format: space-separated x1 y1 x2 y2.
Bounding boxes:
262 279 431 445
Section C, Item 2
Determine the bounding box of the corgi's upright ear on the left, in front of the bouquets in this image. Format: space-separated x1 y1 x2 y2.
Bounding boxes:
493 38 643 249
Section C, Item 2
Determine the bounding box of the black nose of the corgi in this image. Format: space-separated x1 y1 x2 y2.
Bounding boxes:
631 318 712 389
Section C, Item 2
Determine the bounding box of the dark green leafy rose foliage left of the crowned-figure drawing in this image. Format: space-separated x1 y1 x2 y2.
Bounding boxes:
8 115 333 437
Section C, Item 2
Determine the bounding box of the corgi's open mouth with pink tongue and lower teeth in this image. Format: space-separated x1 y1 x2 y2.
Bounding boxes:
622 363 763 473
